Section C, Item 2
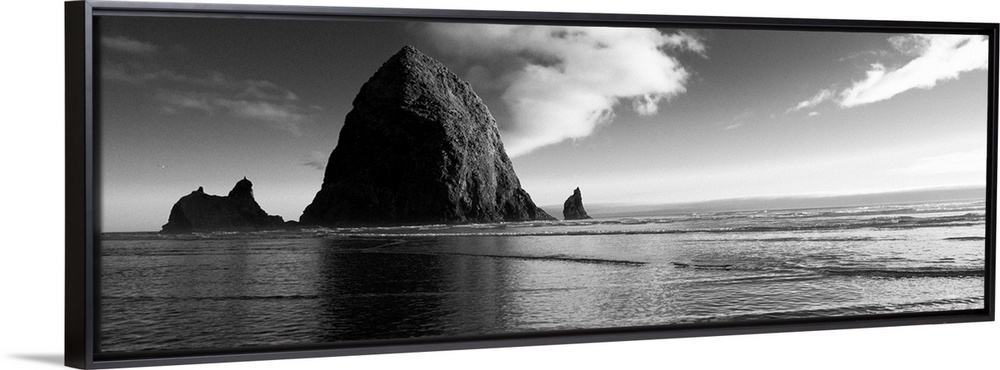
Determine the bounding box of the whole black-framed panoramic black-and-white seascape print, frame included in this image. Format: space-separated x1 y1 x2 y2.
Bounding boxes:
65 1 998 368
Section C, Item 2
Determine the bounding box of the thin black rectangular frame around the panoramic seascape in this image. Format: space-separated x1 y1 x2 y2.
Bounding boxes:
65 1 998 368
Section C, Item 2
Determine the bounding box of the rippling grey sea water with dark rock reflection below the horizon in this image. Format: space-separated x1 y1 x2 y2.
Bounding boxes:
99 201 986 352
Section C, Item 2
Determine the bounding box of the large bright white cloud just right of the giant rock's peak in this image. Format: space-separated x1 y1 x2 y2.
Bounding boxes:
427 23 705 156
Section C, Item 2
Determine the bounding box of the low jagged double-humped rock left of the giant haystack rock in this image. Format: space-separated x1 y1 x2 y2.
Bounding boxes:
160 177 284 233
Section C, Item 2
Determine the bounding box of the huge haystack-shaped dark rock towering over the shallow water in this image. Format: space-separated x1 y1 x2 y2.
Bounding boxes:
299 46 554 226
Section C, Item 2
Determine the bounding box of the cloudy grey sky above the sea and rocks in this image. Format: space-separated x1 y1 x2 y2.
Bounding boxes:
96 16 987 231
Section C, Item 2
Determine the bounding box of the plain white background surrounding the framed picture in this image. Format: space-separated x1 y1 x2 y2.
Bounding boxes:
0 0 1000 370
